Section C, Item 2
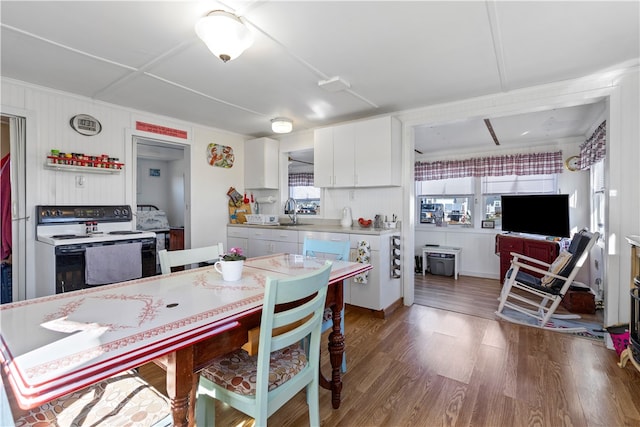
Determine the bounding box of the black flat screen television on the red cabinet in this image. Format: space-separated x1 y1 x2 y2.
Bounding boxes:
501 194 570 237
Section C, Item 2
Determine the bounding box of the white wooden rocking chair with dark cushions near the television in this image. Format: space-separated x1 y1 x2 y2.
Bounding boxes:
495 229 600 333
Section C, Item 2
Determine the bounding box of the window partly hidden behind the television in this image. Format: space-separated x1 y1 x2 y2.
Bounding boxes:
480 174 558 227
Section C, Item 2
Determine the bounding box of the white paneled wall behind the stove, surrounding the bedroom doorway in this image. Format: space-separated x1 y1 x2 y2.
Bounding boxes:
1 79 248 298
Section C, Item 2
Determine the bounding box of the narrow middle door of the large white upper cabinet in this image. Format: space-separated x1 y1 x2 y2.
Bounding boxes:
330 123 356 187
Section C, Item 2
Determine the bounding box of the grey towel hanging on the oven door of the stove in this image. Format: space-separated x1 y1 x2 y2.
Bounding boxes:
84 242 142 285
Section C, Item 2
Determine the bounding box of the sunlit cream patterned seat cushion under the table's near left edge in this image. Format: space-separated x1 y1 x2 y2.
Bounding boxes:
15 371 171 427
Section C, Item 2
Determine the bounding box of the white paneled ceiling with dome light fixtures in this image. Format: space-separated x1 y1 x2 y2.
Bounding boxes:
0 0 640 155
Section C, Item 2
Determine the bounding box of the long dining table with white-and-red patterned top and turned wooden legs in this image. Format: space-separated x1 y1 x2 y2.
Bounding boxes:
0 253 372 426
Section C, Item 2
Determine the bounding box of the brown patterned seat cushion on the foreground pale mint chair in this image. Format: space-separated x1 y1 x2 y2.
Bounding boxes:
200 344 307 396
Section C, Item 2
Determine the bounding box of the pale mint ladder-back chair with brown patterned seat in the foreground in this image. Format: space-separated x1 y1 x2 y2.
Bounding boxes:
196 261 331 426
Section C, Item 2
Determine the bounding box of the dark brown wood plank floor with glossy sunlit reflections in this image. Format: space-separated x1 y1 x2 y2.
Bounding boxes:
135 274 640 427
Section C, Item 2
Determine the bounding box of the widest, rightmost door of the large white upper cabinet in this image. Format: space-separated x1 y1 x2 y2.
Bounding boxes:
355 117 402 187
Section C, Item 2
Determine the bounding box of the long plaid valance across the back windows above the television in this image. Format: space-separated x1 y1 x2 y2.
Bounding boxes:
415 151 562 181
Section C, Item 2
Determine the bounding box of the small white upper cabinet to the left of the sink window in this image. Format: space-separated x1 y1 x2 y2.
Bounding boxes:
244 138 279 190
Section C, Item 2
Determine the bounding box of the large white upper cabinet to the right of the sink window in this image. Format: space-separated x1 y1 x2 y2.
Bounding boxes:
314 117 401 188
